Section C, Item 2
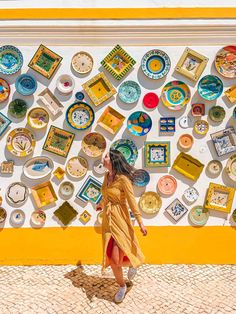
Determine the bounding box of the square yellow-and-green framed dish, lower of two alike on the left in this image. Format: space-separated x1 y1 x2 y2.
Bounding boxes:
43 125 75 157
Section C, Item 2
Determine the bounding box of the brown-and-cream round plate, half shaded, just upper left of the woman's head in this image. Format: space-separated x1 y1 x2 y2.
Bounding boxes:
82 132 106 157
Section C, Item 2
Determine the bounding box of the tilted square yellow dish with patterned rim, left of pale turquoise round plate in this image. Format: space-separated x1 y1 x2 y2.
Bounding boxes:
82 72 116 106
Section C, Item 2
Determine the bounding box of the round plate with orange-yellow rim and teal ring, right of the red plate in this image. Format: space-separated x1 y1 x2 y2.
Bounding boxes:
161 81 191 110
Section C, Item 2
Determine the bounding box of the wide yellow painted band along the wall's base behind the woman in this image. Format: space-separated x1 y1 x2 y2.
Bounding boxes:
0 226 236 265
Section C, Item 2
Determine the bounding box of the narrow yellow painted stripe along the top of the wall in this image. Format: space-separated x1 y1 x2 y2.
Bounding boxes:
0 7 236 20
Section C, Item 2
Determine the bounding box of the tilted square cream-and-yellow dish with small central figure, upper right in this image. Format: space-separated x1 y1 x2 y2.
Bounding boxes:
175 47 209 81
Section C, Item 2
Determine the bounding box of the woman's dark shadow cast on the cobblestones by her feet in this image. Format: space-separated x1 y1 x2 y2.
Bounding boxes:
64 264 133 302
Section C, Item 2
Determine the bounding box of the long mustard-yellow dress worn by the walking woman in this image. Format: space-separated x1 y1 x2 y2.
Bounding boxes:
101 173 145 273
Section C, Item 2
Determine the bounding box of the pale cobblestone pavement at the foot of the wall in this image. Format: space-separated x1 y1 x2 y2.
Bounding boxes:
0 264 236 314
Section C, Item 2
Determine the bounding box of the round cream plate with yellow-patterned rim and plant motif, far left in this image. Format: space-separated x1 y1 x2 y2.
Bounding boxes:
7 128 35 157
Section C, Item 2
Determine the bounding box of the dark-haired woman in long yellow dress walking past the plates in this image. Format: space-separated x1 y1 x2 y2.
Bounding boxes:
97 150 147 303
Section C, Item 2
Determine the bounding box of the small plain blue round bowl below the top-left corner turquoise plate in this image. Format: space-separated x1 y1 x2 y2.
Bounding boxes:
15 74 37 96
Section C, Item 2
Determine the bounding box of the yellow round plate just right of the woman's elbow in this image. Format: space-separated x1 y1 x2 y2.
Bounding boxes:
139 192 162 214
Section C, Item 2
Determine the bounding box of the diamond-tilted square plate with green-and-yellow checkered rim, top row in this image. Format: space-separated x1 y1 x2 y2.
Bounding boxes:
101 45 136 80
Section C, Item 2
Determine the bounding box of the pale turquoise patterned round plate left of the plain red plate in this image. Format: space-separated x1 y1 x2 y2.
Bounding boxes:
118 81 141 104
